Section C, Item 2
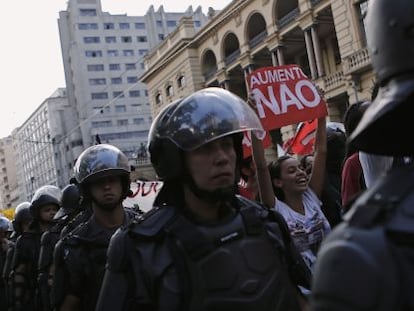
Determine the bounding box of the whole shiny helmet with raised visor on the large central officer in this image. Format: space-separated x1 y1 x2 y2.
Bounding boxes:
148 87 264 180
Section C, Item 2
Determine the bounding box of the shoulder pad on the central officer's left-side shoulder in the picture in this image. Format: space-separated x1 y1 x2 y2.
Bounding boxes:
128 206 175 237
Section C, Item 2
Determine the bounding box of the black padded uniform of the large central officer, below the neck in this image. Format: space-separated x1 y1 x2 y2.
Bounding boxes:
97 199 309 311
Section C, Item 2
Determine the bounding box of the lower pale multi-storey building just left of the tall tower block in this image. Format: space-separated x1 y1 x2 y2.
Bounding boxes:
13 88 83 201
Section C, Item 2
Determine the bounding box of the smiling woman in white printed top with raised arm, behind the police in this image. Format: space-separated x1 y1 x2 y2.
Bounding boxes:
268 118 330 270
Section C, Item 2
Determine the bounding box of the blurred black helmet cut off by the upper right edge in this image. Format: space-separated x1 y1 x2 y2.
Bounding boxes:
351 0 414 156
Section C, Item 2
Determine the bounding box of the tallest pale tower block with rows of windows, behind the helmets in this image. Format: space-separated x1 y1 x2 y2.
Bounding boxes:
58 0 208 165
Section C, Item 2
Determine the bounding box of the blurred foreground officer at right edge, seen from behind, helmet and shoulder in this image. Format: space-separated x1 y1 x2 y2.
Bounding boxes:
312 0 414 311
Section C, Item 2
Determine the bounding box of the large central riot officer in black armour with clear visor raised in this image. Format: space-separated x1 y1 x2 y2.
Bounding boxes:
97 88 309 311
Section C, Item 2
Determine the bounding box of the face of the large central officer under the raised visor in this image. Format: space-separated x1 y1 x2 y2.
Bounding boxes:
186 136 236 191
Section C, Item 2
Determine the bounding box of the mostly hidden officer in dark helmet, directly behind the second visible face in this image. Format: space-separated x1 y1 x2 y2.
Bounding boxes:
37 184 83 311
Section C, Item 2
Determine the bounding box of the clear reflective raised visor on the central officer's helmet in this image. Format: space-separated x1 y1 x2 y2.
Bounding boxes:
153 88 265 151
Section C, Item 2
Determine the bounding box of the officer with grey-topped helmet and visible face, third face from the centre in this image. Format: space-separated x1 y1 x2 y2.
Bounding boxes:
12 185 62 310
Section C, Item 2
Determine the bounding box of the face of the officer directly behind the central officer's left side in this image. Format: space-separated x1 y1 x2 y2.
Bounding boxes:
90 176 122 207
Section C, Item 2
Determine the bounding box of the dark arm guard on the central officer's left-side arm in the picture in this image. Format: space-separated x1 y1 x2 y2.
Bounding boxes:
95 229 129 311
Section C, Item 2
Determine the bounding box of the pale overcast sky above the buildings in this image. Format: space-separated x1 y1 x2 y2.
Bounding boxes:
0 0 231 138
